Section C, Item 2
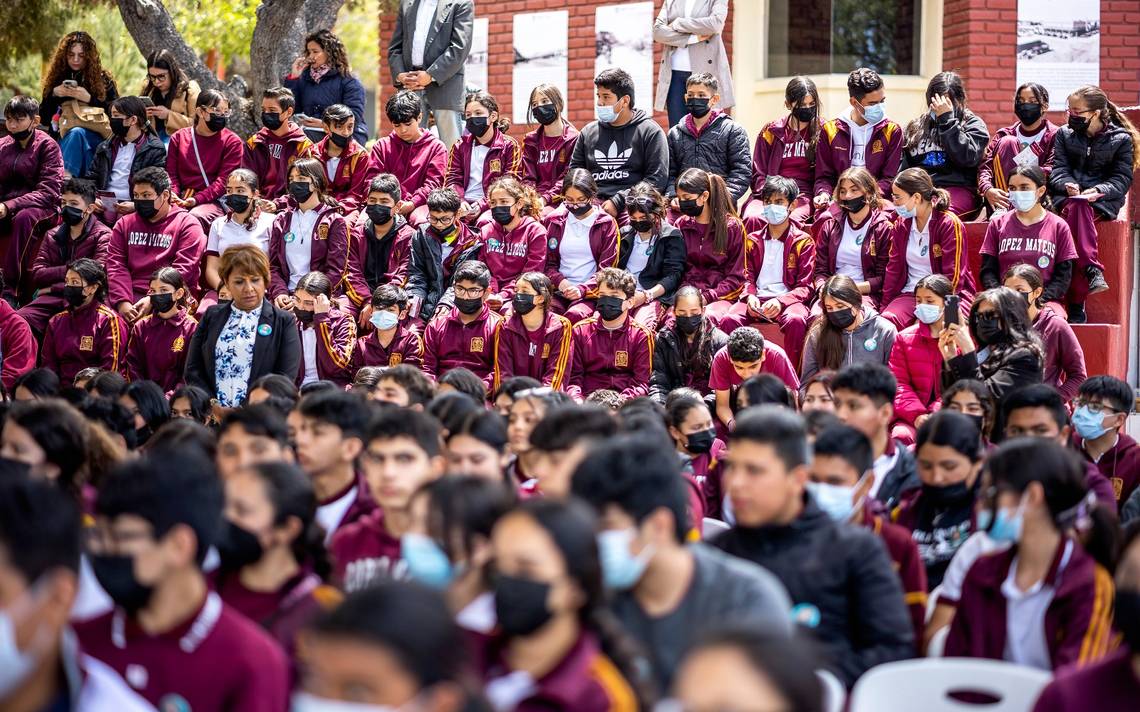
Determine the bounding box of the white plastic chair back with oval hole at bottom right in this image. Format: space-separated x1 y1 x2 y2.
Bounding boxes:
850 657 1052 712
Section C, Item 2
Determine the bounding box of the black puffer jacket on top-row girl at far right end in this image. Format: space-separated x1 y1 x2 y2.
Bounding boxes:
1049 124 1132 220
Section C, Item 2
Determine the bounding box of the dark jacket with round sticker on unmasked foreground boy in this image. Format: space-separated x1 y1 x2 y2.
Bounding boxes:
711 494 914 688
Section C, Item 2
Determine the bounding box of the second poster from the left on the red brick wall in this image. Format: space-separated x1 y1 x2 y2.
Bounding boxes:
511 10 570 123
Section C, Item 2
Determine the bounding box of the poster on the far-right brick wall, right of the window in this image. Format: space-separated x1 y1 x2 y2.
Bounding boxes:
1010 0 1100 101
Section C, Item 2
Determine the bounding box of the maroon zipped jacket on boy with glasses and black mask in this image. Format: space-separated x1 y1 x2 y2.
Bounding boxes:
423 304 503 392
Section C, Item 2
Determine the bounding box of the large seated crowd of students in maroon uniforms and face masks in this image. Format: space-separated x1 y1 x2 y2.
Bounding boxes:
0 26 1140 712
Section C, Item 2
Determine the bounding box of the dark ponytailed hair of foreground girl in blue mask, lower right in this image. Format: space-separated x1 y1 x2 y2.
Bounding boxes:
986 437 1121 573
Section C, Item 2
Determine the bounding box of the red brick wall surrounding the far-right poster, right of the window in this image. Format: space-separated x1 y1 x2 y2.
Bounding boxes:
942 0 1140 130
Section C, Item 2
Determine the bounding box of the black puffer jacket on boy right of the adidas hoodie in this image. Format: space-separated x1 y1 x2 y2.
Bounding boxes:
666 114 752 202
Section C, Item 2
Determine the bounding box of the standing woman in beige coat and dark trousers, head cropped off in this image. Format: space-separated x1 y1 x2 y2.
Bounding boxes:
653 0 736 126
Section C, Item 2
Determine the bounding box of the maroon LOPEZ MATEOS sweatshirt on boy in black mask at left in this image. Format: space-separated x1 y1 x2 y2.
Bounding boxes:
106 205 206 306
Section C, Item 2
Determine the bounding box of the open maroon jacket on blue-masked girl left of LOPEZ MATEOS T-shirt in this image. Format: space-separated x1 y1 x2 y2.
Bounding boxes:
882 210 974 305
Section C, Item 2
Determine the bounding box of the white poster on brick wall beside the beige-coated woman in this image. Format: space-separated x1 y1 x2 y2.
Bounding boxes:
594 2 654 112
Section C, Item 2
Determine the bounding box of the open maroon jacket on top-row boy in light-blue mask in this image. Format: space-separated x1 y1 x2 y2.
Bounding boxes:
815 118 903 199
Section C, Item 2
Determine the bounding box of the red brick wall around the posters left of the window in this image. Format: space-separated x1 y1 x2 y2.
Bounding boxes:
376 0 729 138
